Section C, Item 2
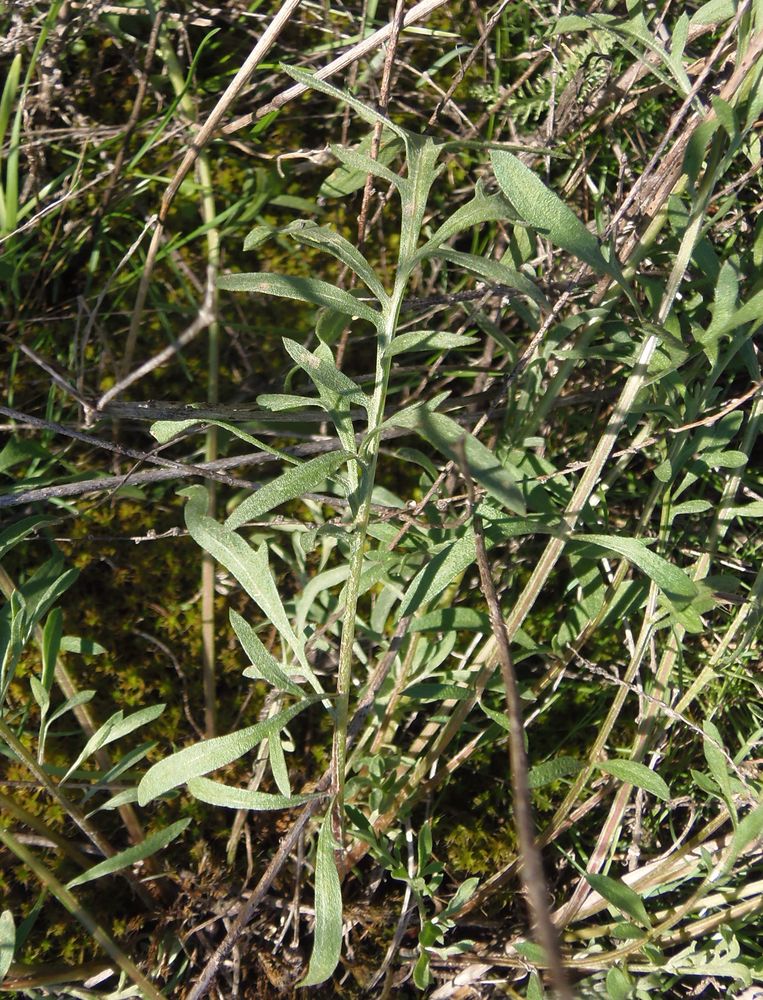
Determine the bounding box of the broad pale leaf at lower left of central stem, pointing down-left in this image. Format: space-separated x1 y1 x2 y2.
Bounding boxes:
138 698 314 806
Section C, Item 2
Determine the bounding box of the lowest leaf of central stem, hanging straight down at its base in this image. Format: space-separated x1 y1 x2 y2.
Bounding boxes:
297 810 342 986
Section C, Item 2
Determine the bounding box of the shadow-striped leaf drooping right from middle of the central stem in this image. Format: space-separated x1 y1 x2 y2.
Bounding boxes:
389 406 525 514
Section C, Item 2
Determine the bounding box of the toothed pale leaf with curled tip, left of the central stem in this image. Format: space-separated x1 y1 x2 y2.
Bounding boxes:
179 486 309 671
